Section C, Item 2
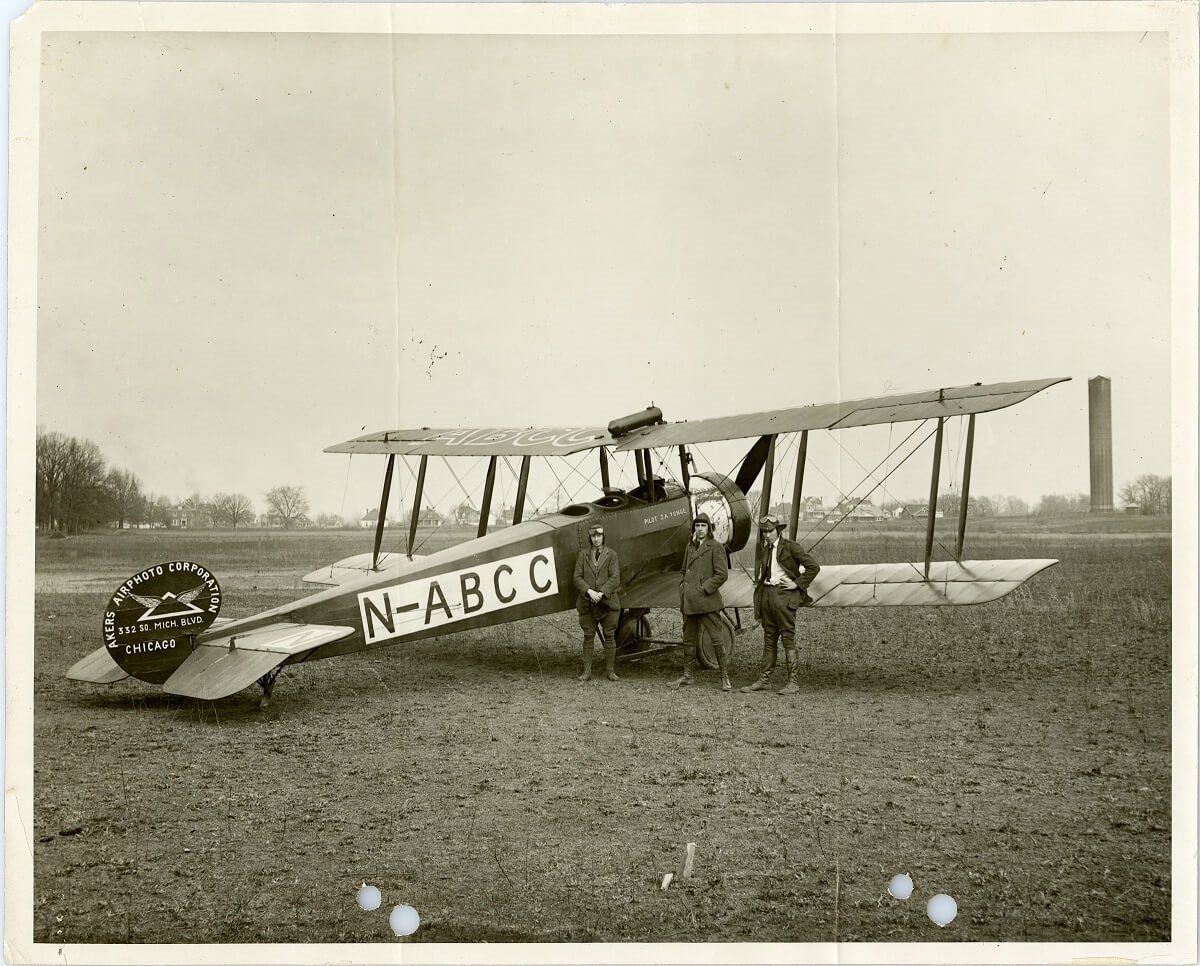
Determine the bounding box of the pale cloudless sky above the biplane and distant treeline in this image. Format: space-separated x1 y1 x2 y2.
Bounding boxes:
28 11 1172 517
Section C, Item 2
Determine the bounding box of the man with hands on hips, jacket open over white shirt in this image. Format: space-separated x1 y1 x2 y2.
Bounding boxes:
740 514 821 695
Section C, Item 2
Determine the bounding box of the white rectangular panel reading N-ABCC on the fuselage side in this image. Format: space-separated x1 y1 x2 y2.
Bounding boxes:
359 547 558 644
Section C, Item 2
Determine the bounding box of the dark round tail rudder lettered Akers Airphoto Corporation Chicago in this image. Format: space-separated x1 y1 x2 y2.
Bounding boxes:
104 560 221 684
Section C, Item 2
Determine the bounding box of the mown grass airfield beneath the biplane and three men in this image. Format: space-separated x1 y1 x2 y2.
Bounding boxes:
30 521 1171 943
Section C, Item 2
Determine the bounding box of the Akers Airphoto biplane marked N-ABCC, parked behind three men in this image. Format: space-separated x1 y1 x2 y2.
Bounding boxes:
67 378 1066 703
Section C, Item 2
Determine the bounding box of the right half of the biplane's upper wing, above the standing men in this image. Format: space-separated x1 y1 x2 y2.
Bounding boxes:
617 377 1070 452
